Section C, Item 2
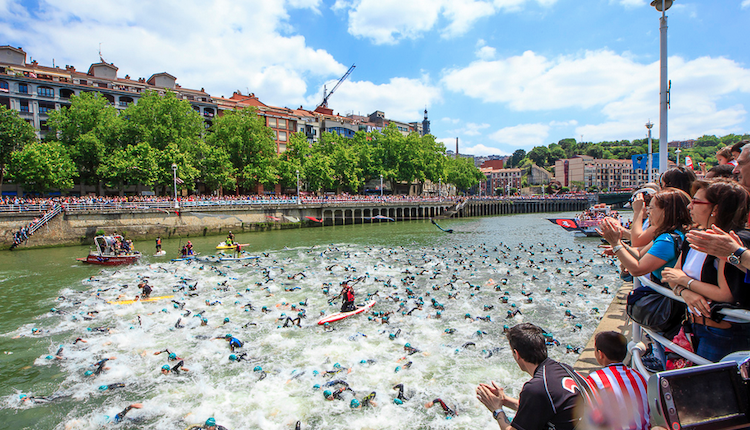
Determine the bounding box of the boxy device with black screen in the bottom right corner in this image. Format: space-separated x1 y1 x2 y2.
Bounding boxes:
648 352 750 430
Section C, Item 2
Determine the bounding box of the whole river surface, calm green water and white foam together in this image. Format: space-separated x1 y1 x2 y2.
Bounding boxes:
0 213 620 430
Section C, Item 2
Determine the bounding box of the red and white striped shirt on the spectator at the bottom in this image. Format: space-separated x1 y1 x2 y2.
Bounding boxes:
586 363 651 430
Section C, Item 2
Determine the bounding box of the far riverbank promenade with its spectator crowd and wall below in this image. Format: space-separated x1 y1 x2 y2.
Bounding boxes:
0 195 595 249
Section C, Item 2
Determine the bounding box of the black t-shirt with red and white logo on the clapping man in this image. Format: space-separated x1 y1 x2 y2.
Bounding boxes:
511 358 581 430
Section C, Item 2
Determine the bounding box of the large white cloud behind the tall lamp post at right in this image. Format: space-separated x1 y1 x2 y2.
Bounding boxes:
442 50 750 141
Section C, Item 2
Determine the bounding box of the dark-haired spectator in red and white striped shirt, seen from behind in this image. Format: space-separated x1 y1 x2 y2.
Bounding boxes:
587 331 651 430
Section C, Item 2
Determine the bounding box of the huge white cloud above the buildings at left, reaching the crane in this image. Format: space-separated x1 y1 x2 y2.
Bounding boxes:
0 0 346 106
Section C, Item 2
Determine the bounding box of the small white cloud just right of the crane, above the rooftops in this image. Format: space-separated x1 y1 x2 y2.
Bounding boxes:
318 78 442 122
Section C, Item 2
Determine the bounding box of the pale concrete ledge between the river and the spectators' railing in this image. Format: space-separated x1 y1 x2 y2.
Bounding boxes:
573 282 633 376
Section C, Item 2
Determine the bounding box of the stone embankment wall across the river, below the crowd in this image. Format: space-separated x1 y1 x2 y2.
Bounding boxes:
0 199 588 249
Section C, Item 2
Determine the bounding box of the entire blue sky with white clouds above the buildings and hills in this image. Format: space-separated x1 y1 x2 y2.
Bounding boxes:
0 0 750 156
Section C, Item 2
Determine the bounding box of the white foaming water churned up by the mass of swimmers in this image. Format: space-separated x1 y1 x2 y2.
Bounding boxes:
3 240 619 429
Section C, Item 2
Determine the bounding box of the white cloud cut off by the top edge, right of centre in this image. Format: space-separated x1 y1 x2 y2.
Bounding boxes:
332 0 557 45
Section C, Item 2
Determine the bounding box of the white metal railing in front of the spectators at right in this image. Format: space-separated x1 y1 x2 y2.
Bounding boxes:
628 276 750 379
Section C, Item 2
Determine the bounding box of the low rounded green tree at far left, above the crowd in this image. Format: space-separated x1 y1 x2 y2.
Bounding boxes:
9 142 76 193
